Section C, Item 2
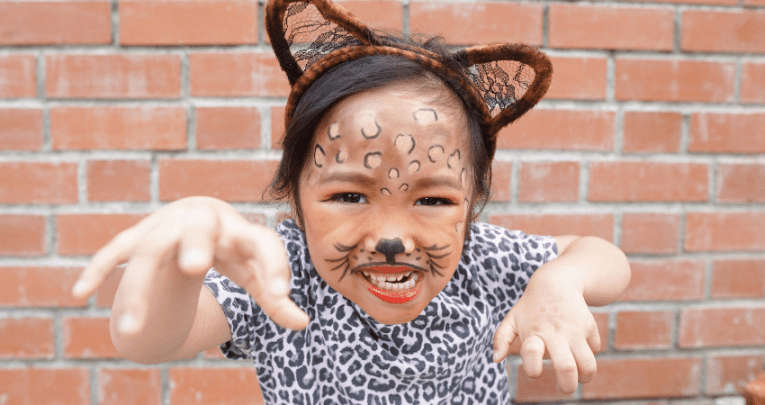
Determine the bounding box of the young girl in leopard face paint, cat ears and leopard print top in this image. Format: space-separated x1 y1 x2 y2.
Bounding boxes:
74 1 629 404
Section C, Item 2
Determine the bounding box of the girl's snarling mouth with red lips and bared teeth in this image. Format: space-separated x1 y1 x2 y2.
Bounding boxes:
359 266 423 304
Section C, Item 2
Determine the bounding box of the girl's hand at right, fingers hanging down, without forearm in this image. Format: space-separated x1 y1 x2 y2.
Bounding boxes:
494 261 600 394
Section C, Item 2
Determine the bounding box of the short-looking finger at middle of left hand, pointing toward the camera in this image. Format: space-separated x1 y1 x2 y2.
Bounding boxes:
178 205 220 275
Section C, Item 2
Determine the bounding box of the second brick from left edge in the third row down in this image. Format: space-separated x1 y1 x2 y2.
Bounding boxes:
50 106 186 150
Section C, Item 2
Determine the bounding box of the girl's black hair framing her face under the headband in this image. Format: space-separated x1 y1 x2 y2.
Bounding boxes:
267 36 491 229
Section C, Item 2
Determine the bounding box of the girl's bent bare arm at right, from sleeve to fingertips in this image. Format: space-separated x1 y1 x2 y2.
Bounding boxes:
494 236 630 393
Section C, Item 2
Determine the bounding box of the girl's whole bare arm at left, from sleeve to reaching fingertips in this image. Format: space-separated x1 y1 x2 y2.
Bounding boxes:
73 197 308 363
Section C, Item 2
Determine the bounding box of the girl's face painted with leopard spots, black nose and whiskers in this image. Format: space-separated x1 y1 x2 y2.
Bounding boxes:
299 84 472 324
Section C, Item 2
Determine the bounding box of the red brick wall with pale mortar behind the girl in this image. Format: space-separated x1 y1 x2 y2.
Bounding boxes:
0 0 765 405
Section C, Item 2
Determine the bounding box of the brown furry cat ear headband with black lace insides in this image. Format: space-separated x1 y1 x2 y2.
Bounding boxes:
266 0 552 157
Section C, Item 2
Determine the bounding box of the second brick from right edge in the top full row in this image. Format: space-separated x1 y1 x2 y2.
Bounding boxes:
548 4 674 51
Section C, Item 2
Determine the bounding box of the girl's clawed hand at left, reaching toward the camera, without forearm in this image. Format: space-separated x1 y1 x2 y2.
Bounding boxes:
73 197 309 333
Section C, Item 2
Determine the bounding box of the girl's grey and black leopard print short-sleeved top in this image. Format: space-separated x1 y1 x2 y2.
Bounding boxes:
205 220 558 405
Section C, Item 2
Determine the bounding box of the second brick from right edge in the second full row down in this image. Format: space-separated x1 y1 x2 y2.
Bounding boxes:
615 58 736 102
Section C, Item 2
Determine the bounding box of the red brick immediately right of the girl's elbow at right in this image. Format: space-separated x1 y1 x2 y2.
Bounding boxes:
619 260 706 301
